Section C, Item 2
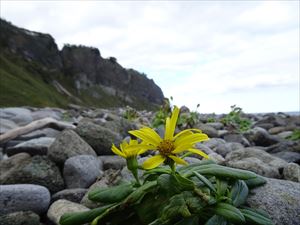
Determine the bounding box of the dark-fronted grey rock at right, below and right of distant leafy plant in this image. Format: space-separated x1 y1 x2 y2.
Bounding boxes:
244 127 279 146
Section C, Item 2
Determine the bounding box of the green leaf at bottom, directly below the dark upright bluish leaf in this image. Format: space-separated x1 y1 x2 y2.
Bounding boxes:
214 203 245 224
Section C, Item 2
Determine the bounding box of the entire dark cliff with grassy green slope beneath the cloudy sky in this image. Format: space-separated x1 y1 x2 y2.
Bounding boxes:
0 19 164 109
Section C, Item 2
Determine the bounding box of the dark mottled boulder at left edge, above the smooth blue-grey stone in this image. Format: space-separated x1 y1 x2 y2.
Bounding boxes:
0 153 64 193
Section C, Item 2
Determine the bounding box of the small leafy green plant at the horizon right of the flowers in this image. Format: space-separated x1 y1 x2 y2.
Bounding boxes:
221 105 252 132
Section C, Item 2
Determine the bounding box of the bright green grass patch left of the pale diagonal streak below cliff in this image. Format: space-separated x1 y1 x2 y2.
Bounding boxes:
0 55 68 107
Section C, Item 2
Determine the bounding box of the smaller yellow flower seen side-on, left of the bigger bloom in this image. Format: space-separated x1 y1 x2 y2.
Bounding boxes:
111 139 146 159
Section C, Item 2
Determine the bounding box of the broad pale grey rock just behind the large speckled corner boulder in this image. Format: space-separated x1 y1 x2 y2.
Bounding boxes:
225 148 287 178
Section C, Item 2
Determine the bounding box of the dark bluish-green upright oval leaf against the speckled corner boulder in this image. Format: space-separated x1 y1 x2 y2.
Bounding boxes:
229 180 249 206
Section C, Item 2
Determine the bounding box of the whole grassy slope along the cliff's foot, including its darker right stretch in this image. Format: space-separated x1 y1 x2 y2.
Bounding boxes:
0 54 155 109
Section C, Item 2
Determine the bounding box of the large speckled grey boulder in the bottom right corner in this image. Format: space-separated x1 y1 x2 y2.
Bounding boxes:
247 179 300 225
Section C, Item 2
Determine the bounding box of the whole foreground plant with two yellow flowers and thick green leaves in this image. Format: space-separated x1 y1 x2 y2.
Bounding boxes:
60 107 273 225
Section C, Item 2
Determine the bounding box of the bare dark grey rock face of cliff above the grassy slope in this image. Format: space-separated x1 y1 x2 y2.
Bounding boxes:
0 20 164 106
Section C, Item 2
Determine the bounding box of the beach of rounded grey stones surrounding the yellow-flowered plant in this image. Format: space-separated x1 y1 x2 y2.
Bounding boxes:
0 105 300 225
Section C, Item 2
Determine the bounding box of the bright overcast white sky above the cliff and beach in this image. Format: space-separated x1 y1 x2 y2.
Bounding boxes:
0 0 300 113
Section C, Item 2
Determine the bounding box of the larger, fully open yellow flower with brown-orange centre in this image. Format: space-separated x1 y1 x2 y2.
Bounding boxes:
129 106 208 169
